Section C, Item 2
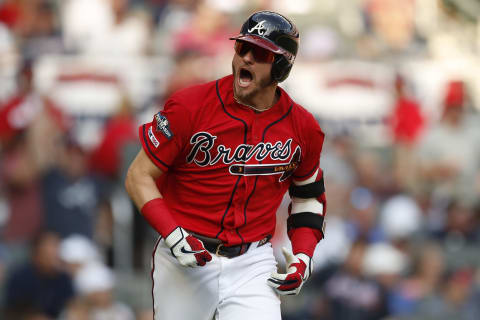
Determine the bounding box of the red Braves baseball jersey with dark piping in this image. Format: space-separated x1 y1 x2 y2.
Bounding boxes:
139 75 324 245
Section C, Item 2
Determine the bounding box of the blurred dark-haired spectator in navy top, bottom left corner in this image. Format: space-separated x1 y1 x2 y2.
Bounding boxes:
6 232 74 319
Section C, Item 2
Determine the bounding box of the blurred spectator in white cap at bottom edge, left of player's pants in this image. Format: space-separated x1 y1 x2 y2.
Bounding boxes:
61 263 135 320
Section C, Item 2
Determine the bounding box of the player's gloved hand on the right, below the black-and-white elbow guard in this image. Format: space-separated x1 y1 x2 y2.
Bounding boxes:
267 247 313 295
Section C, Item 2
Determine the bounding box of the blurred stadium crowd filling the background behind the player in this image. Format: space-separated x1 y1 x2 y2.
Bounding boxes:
0 0 480 320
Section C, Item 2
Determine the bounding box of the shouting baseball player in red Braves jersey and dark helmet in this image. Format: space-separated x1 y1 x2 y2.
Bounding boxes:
125 11 326 320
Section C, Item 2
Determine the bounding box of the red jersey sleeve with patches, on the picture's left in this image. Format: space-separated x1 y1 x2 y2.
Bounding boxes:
139 97 192 172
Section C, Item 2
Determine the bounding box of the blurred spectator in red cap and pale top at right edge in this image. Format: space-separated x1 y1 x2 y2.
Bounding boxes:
418 81 480 205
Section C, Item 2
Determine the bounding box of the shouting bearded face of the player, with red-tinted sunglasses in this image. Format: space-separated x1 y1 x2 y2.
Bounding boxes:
232 40 275 102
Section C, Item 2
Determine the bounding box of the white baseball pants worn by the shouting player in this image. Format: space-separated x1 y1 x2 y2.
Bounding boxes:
152 240 281 320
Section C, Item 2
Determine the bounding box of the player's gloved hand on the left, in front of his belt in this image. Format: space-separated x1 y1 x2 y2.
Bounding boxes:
165 227 212 267
